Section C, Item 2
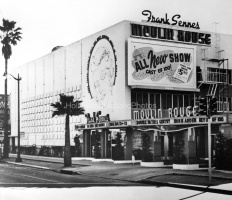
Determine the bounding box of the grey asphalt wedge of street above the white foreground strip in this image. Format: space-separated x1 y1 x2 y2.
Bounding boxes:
0 163 141 188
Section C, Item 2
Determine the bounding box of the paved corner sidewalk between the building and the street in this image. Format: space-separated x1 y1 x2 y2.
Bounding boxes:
2 154 232 194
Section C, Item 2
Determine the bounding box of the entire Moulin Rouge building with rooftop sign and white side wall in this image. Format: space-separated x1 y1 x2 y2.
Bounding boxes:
11 11 232 164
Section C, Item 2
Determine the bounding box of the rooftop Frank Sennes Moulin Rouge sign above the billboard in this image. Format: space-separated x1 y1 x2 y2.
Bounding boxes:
131 10 211 45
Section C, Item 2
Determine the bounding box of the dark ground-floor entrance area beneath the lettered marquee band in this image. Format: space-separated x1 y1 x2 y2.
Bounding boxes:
82 126 212 164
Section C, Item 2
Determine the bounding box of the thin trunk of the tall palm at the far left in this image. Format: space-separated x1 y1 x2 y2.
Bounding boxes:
3 59 9 158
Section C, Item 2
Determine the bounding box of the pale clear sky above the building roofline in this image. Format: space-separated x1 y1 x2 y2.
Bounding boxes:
0 0 232 93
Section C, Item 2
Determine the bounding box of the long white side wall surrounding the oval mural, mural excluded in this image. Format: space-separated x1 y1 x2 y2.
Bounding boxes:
11 22 131 146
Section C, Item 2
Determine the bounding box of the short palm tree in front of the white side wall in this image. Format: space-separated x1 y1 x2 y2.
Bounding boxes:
51 94 85 167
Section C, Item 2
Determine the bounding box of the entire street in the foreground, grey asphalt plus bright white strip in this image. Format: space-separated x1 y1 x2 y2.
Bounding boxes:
0 163 231 200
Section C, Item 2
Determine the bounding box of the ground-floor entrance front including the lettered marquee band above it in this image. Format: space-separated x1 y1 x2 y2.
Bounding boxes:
76 117 226 164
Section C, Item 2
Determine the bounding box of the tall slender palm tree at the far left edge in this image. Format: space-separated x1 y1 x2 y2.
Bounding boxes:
0 19 22 158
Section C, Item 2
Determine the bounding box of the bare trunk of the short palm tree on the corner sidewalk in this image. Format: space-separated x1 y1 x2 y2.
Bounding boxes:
64 113 72 167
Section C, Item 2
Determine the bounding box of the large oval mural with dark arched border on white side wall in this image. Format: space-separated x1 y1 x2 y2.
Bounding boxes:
87 35 117 107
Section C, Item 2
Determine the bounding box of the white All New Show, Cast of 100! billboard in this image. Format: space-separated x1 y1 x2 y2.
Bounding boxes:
128 38 196 90
